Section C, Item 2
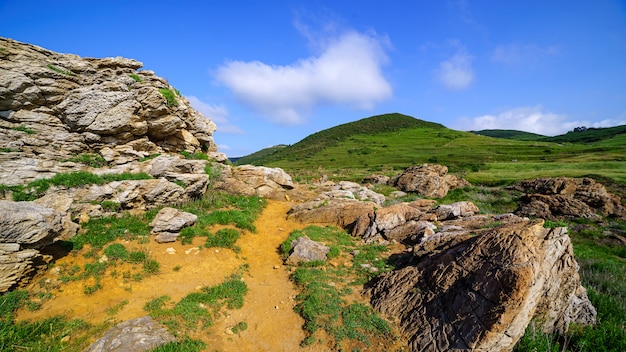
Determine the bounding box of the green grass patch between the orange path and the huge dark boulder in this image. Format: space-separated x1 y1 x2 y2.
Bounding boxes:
280 226 393 350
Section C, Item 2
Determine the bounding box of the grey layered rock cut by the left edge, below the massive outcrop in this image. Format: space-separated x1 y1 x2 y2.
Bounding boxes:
0 200 78 292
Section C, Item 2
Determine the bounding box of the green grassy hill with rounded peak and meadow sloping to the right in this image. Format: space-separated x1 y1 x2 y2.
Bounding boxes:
235 114 626 185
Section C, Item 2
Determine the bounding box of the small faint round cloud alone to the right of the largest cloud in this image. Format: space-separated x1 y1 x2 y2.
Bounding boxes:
436 47 474 90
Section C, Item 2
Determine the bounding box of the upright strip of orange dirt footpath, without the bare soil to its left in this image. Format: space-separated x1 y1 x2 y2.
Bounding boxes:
200 201 321 352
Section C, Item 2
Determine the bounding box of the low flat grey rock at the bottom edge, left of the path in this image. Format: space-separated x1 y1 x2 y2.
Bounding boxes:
86 316 176 352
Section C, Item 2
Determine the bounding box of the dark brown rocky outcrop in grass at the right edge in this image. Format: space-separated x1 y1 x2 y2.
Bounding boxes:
515 177 626 220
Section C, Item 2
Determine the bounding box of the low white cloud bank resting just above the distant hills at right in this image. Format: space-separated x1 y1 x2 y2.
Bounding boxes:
455 105 572 136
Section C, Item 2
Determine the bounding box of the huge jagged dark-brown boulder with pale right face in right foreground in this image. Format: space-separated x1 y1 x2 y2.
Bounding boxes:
370 220 596 351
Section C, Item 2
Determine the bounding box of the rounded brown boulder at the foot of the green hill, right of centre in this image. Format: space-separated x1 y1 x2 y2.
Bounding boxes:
392 164 471 198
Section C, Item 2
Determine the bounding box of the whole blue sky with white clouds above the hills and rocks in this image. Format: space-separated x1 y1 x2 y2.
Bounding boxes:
0 0 626 157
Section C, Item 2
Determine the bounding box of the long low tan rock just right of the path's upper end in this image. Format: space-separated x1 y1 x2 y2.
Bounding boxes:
287 199 379 231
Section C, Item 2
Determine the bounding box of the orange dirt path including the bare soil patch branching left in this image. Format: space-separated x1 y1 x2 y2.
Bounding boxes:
17 201 324 352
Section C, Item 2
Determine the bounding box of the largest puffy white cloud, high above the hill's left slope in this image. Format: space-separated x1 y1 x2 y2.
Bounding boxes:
216 32 392 125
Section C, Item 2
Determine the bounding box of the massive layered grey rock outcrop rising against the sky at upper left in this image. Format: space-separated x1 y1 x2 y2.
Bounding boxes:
0 38 223 185
